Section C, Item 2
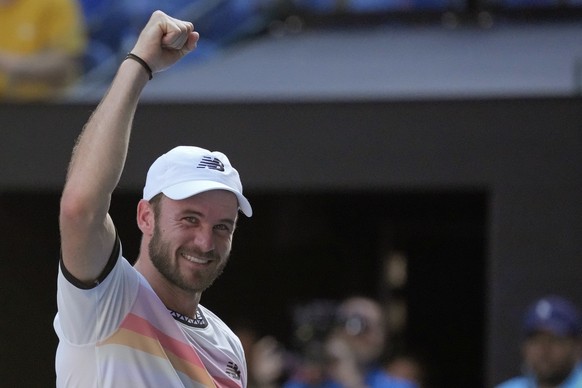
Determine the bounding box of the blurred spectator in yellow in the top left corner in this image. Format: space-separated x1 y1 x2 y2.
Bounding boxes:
0 0 86 101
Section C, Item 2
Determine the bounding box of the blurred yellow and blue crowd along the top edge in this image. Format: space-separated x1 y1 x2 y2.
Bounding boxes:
0 0 581 101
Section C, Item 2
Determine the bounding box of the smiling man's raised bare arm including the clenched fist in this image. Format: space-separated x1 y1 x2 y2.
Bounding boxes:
59 11 198 284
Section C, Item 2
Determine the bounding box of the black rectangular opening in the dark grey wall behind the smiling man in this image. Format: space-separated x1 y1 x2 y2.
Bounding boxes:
1 191 487 387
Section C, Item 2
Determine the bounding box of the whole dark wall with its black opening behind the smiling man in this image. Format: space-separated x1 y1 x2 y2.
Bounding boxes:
0 97 582 387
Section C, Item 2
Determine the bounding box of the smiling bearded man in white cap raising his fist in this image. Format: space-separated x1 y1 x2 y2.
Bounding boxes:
54 11 252 388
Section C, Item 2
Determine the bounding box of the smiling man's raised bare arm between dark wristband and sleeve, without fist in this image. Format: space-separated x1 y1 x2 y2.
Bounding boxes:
59 56 148 284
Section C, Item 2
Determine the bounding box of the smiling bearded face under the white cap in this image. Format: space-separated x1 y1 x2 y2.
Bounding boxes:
149 190 238 294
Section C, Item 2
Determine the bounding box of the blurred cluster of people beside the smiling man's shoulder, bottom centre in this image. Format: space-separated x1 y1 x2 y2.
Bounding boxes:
235 296 427 388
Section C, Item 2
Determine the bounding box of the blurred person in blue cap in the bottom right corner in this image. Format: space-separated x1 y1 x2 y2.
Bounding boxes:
497 296 582 388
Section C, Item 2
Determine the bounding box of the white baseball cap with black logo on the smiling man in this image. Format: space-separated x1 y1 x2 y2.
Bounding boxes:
143 146 253 217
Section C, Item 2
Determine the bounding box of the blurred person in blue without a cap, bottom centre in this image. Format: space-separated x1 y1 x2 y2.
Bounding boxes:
285 297 415 388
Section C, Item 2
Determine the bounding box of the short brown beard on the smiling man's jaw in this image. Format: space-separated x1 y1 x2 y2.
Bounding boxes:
148 225 228 294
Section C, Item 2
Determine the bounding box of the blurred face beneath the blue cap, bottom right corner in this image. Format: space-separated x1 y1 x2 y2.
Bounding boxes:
523 331 580 386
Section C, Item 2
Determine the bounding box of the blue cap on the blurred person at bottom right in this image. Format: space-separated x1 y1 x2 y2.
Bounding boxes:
524 295 582 337
